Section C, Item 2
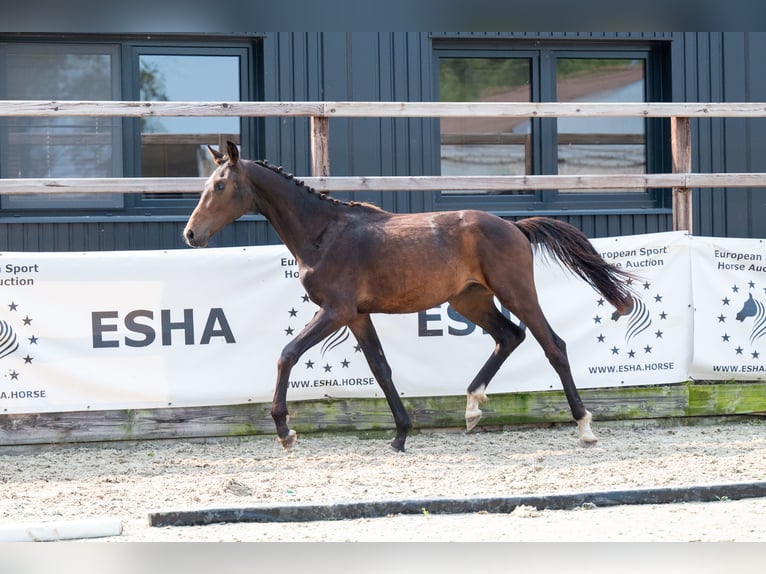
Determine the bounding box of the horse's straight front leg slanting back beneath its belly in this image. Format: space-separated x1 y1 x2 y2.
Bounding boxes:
349 315 412 452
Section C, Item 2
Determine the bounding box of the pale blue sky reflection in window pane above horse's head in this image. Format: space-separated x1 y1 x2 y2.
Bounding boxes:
141 55 239 134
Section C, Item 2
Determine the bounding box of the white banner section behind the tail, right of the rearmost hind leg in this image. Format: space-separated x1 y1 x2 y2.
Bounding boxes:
543 232 693 388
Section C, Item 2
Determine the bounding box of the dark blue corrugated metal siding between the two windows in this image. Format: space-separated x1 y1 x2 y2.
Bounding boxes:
263 32 436 212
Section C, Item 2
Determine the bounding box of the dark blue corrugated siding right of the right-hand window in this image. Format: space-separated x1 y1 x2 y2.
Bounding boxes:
672 32 766 238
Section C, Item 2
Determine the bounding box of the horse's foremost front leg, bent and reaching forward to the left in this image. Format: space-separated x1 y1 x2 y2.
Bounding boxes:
271 309 342 450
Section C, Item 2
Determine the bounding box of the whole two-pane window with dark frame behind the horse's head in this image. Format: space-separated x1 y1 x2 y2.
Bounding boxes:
0 41 255 215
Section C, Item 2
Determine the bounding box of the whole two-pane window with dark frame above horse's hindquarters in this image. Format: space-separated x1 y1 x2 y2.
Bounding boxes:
435 44 669 214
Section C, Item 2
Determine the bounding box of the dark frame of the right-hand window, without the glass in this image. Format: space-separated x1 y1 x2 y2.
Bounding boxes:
433 40 672 216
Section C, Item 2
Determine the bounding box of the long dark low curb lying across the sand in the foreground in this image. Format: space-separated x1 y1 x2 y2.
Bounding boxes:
149 482 766 527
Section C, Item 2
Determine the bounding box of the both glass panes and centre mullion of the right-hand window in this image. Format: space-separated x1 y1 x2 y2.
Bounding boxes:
439 54 647 197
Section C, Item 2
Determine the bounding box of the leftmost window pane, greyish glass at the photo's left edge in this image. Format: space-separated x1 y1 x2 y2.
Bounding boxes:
0 44 122 209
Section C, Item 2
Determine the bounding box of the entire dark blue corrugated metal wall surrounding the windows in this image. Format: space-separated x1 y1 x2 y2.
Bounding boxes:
6 32 766 251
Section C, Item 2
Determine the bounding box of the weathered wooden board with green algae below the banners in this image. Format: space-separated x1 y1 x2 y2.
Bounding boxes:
0 382 766 447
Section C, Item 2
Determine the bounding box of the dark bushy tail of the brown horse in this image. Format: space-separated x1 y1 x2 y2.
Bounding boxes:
514 217 635 312
